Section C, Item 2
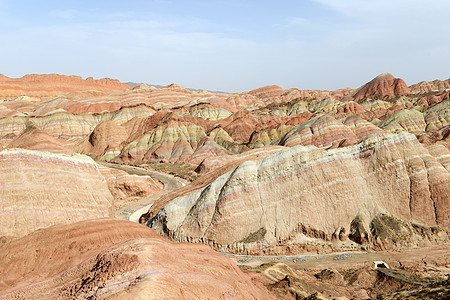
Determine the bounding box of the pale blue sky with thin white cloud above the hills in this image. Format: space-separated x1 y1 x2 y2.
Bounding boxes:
0 0 450 92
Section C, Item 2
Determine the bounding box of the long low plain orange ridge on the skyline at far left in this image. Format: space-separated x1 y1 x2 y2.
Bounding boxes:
0 74 131 99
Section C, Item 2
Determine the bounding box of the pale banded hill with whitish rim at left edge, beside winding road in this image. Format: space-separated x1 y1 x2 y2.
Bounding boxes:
0 149 113 237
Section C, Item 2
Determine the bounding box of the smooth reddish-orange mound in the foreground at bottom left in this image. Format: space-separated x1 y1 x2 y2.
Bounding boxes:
0 218 274 299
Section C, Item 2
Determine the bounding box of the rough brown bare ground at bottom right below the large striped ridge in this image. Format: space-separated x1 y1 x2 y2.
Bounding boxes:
230 244 450 299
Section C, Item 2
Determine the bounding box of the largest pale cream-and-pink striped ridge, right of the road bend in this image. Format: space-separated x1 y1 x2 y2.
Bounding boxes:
148 133 450 253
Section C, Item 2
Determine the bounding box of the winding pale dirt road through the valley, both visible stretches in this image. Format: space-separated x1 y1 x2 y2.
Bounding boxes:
99 162 450 273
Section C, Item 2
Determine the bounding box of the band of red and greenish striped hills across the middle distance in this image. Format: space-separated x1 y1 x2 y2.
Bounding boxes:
0 74 449 165
